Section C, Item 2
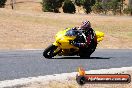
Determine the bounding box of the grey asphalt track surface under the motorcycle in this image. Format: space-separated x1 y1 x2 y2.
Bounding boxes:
0 49 132 81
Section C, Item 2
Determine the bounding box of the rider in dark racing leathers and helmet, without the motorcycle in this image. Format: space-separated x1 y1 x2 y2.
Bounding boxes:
71 21 97 48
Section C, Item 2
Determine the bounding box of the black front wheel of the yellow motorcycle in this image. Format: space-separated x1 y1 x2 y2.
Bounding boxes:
43 44 57 58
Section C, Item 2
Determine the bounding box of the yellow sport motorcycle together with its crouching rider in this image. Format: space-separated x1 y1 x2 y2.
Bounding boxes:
43 21 104 58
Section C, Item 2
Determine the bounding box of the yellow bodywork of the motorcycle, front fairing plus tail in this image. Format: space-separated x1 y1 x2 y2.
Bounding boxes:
53 28 104 49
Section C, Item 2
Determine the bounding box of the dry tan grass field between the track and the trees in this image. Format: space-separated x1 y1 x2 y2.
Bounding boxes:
0 9 132 49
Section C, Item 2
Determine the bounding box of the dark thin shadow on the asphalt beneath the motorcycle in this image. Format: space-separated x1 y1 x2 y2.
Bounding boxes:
52 56 112 59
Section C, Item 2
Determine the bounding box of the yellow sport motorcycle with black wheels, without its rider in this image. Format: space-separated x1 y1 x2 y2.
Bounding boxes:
43 28 104 58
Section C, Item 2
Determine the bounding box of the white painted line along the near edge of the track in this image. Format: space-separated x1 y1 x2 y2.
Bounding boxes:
0 67 132 88
